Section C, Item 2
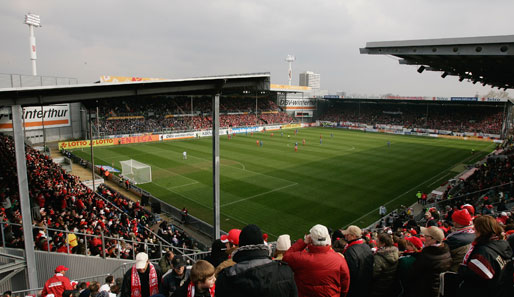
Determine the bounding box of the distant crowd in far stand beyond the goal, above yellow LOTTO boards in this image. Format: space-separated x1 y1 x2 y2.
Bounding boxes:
92 97 293 135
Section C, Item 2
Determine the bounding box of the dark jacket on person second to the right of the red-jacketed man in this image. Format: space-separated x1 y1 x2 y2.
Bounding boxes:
370 246 400 296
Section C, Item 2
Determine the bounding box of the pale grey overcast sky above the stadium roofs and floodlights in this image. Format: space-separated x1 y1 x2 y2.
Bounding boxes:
0 0 514 96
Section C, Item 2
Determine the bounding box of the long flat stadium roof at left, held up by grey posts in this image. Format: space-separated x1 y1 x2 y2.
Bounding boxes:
0 72 270 106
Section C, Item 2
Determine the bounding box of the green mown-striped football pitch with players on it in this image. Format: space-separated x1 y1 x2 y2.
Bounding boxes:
69 128 495 239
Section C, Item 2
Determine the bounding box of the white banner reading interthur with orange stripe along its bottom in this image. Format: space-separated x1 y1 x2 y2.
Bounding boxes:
0 104 71 131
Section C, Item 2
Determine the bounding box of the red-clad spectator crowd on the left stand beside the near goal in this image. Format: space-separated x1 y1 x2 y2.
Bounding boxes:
0 135 194 259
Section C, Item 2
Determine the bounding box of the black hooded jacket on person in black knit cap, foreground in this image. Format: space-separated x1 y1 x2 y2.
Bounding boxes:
215 244 298 297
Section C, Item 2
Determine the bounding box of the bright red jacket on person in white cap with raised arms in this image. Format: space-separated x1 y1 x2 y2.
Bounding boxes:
282 239 350 297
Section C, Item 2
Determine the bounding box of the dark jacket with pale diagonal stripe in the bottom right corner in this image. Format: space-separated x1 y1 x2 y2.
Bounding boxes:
458 240 514 297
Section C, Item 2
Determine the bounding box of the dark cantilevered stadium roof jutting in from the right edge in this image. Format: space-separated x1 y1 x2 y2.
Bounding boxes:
360 35 514 89
